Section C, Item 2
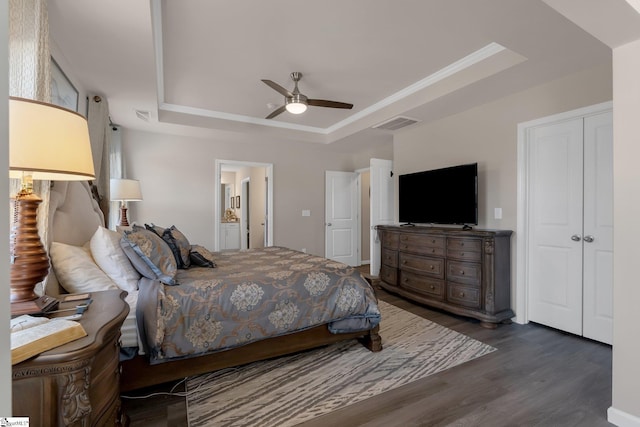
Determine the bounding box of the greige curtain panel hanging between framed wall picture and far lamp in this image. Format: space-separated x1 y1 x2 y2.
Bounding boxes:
87 95 111 221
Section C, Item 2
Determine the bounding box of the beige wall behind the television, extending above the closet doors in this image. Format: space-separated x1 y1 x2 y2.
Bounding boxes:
393 64 612 307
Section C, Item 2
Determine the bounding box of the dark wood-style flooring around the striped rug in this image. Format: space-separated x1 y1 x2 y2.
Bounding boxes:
122 270 612 427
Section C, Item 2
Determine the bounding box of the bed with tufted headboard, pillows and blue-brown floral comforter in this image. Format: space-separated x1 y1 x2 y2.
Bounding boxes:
44 182 382 391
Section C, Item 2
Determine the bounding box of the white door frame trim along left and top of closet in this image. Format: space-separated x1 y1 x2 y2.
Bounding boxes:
515 101 613 324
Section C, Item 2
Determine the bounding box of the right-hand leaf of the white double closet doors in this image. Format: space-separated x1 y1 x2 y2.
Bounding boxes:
582 112 613 344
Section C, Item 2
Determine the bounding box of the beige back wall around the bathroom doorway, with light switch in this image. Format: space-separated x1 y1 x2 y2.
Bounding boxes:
123 129 392 255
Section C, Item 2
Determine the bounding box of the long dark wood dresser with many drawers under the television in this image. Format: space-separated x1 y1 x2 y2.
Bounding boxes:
377 225 514 328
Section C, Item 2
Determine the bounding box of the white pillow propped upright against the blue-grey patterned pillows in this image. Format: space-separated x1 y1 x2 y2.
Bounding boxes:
89 226 141 292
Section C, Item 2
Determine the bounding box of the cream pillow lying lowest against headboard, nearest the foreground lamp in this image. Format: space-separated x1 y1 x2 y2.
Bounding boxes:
49 242 118 294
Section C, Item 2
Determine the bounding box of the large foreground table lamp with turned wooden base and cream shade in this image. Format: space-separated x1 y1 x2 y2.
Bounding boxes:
9 97 95 315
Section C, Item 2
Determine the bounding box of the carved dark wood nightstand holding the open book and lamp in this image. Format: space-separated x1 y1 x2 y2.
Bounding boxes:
13 290 129 426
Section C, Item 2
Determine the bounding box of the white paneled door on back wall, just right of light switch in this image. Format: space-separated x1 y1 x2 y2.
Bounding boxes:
325 171 358 266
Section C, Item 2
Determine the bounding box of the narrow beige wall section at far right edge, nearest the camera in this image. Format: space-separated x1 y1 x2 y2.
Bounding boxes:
609 40 640 425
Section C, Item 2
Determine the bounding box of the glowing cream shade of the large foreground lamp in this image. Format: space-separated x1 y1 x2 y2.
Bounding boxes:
9 97 95 181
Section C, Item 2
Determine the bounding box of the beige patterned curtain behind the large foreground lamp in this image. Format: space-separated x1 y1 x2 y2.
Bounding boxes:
9 0 51 260
